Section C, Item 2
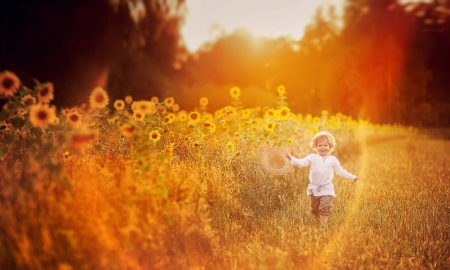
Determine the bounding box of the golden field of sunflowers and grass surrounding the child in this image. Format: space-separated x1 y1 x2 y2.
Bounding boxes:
0 71 450 270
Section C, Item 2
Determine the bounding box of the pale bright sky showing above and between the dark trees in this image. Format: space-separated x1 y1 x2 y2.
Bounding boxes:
181 0 432 52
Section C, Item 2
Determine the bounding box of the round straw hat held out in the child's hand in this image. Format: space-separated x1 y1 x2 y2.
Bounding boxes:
261 147 290 175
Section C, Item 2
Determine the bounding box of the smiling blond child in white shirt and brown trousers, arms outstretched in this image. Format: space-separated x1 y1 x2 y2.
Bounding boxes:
286 131 358 227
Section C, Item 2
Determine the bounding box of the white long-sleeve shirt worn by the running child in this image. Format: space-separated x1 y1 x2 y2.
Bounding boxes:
291 154 357 197
